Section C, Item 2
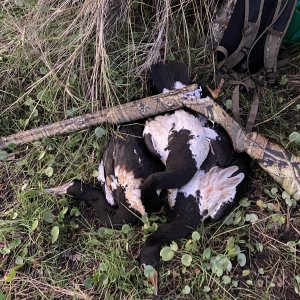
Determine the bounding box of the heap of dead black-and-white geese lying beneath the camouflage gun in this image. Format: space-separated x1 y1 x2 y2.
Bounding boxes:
48 62 249 282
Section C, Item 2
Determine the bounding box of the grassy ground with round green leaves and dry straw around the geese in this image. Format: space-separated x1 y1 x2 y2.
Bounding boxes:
0 0 300 300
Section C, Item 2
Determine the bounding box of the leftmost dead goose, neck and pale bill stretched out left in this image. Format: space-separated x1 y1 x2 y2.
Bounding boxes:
47 124 164 228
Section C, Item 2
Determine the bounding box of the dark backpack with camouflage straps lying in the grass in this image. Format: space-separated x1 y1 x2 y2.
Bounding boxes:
211 0 297 132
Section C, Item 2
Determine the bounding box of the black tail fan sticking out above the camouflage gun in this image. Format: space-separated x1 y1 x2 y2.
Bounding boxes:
150 61 189 93
